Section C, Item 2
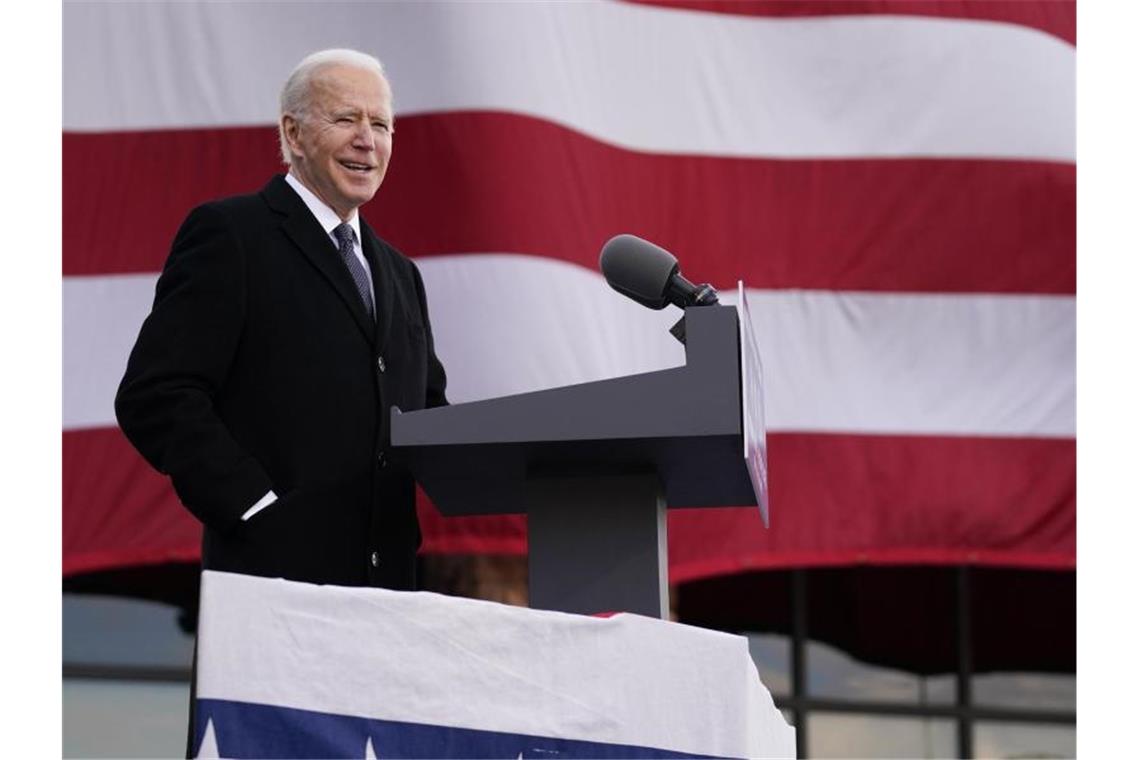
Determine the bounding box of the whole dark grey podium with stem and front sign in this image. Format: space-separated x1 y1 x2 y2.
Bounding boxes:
391 300 766 618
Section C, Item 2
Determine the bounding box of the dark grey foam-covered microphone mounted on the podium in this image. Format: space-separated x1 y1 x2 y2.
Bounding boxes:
597 235 717 309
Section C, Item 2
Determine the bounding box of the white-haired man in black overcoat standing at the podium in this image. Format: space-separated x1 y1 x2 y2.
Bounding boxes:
115 50 447 589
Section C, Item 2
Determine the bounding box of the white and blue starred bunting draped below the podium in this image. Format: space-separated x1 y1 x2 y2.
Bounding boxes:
195 571 795 758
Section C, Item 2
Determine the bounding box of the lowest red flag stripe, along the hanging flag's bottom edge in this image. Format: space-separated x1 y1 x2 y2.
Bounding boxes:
63 428 1076 582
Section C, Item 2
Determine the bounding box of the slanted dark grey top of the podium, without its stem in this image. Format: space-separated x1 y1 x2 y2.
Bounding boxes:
391 307 757 515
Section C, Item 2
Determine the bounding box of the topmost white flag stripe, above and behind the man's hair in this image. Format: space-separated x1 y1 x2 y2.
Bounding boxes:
64 2 1076 161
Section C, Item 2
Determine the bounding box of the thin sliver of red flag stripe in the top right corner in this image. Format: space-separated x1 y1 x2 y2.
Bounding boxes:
627 0 1076 44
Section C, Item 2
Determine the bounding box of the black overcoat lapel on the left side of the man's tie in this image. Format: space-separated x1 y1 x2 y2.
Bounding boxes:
262 175 380 343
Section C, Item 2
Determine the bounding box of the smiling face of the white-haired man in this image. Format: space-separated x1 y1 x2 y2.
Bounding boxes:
282 66 392 220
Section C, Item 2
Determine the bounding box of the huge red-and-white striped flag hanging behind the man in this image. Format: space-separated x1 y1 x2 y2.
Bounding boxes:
63 0 1076 581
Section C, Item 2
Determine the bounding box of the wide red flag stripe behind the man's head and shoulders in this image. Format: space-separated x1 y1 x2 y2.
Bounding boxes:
64 113 1076 294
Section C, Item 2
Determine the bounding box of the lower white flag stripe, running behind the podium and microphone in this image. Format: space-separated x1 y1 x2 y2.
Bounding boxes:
64 254 1076 438
